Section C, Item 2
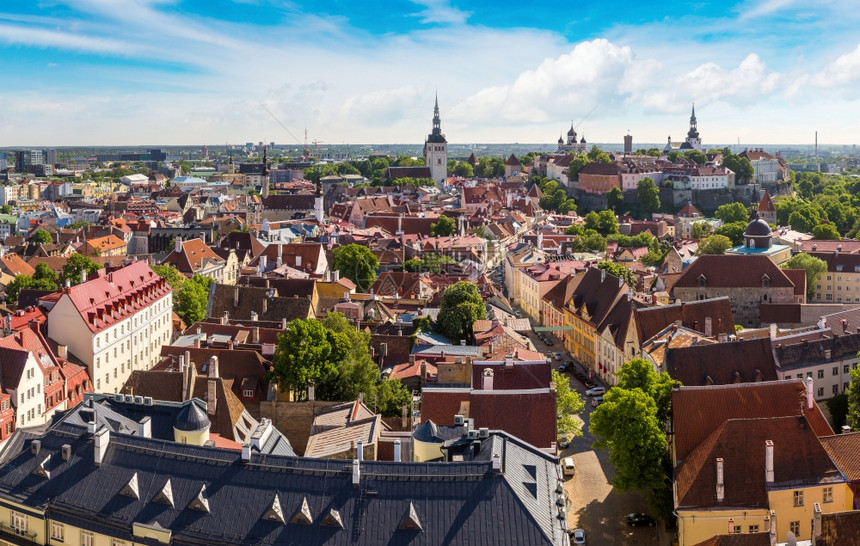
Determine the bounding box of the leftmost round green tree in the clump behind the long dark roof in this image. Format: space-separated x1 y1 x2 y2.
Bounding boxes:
266 319 339 398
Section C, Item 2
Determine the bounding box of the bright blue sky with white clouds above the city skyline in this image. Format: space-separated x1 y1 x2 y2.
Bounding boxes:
0 0 860 146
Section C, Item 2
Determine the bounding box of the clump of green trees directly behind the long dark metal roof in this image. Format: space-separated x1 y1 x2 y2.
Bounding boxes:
267 313 411 417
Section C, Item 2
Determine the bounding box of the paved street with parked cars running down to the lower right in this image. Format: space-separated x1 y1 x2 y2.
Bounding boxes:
529 326 661 545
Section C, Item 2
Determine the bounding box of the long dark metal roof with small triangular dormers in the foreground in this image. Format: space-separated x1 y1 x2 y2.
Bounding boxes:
0 416 567 545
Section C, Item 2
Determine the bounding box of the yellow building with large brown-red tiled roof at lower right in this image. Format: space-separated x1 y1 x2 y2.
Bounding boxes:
672 380 854 546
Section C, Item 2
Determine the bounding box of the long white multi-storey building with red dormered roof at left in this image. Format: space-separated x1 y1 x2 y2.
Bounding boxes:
48 262 173 393
